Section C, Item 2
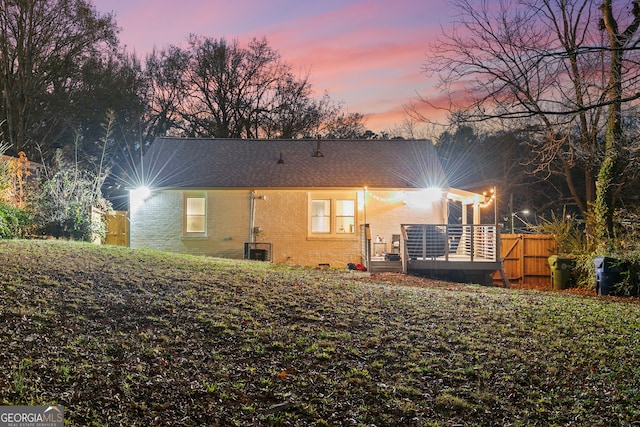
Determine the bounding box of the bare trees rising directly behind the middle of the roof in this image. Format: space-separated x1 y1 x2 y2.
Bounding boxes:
147 35 364 138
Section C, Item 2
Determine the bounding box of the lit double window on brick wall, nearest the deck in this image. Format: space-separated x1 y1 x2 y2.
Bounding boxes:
310 198 356 236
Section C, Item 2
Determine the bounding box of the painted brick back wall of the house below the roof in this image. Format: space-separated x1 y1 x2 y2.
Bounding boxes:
130 190 446 268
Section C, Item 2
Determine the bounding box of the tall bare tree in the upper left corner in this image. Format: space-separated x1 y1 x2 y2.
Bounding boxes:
0 0 117 158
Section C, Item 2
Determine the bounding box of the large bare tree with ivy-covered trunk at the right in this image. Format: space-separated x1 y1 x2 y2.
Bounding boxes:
424 0 640 246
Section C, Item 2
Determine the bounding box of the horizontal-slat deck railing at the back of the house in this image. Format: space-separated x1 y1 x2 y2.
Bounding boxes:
401 224 498 262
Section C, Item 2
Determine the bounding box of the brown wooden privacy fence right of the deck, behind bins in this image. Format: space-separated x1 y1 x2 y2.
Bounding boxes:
493 234 558 287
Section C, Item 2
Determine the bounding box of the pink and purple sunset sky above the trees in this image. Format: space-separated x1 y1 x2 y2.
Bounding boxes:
92 0 453 132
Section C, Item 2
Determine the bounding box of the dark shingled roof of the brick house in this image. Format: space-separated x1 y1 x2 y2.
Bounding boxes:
143 137 447 188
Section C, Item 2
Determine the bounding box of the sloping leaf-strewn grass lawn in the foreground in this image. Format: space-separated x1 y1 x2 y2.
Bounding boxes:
0 241 640 426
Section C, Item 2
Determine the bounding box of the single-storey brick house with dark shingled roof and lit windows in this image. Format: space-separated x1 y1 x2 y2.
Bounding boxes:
129 138 495 280
